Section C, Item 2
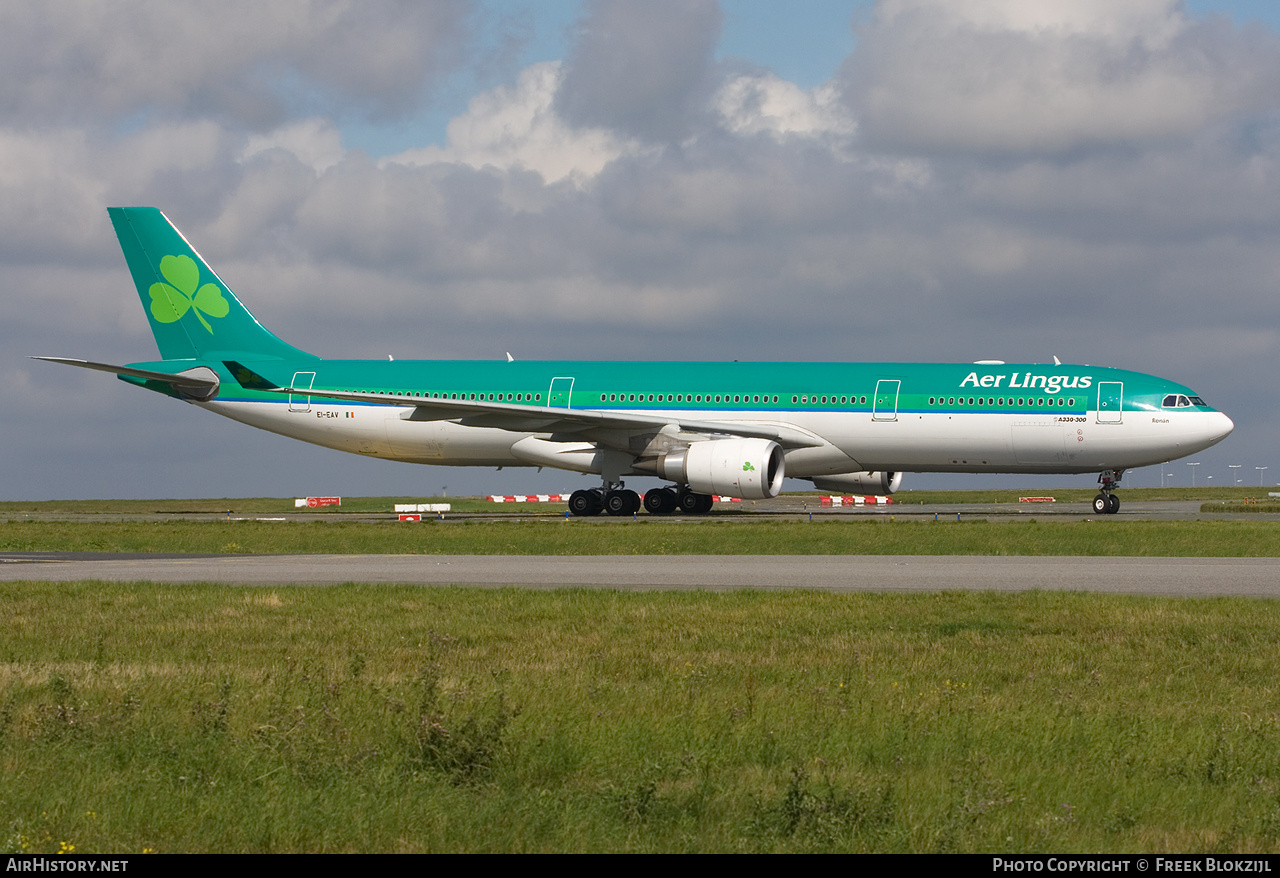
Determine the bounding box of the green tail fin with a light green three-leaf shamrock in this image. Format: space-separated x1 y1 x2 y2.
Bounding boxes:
108 207 315 361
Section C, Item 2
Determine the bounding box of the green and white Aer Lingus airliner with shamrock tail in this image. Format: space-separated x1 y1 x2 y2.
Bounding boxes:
40 207 1233 516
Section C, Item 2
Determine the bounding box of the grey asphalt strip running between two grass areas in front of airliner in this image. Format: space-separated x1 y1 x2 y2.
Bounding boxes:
0 553 1280 598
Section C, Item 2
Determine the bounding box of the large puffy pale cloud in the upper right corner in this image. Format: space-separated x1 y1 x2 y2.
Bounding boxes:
844 0 1280 155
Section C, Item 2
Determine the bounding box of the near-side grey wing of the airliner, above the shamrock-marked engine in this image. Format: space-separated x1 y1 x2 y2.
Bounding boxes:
270 388 826 448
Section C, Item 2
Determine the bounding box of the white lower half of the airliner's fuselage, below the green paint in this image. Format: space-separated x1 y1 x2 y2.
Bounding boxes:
198 401 1221 477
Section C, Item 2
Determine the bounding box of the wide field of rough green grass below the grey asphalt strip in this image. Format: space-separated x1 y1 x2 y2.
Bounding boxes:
0 582 1280 854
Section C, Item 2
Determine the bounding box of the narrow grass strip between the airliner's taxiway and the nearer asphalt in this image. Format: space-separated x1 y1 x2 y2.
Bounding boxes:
0 516 1280 557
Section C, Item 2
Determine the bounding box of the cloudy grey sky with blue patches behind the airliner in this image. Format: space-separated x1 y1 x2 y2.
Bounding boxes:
0 0 1280 499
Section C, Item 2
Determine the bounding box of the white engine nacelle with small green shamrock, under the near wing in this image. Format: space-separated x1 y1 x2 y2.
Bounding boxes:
658 439 786 500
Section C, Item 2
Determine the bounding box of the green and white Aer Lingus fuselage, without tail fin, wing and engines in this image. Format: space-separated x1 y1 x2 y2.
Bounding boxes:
122 360 1231 477
